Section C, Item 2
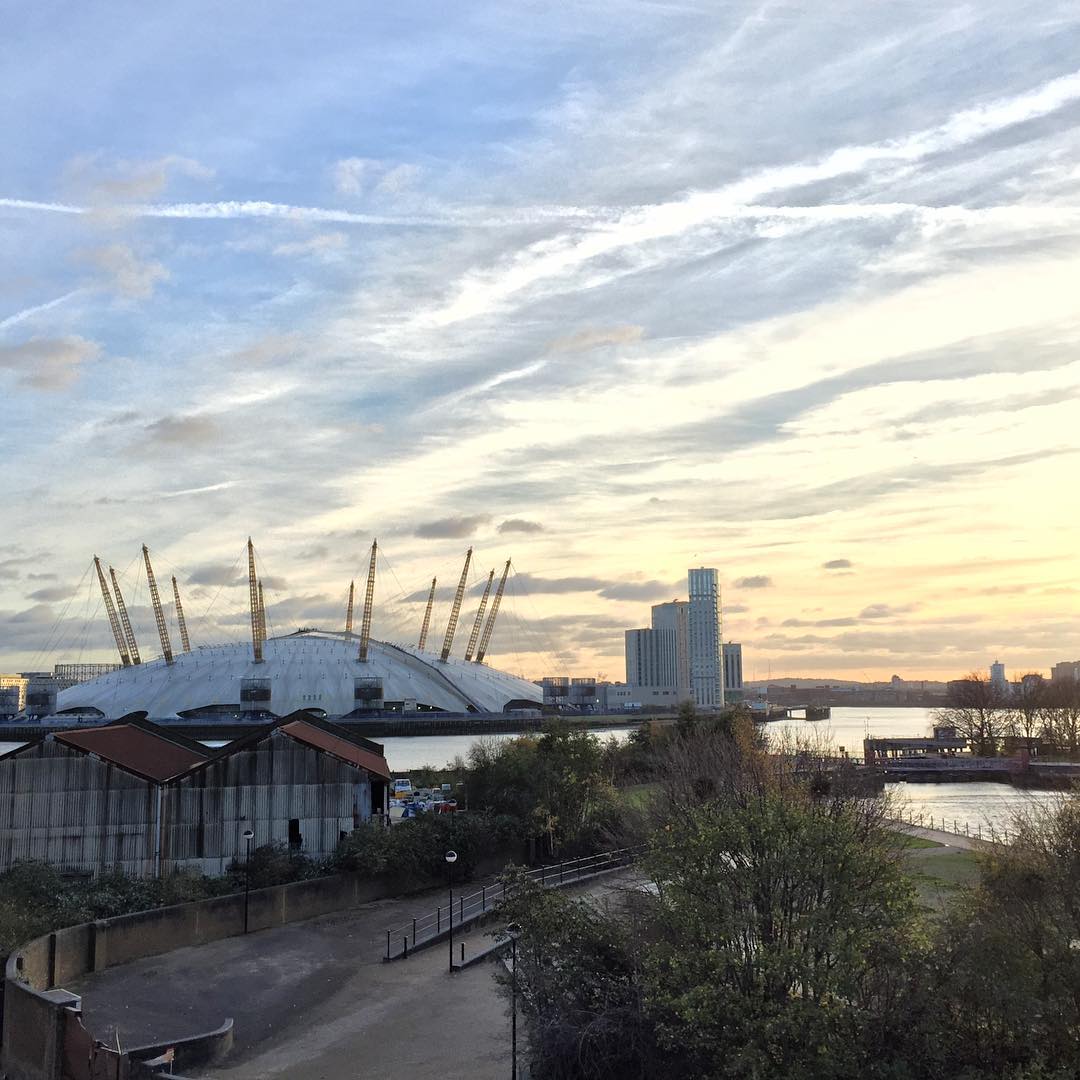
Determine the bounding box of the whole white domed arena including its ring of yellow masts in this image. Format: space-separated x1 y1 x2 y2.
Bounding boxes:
56 541 543 720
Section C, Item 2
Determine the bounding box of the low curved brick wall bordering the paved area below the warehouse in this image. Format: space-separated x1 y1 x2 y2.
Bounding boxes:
0 855 516 1080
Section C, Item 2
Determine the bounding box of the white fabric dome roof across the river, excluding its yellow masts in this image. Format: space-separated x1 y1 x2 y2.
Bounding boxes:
57 630 543 719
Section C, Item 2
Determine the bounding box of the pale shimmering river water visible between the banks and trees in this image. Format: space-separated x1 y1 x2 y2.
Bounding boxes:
0 707 1061 835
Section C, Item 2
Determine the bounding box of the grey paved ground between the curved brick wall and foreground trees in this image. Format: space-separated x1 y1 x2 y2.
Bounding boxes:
68 873 633 1080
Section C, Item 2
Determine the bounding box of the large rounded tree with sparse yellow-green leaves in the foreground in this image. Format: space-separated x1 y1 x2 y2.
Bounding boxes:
645 792 919 1080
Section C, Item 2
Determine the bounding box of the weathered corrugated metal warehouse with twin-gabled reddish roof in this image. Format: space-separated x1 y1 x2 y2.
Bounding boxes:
0 715 390 876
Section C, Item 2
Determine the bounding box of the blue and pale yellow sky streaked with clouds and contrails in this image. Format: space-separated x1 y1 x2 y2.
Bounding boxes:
0 0 1080 679
